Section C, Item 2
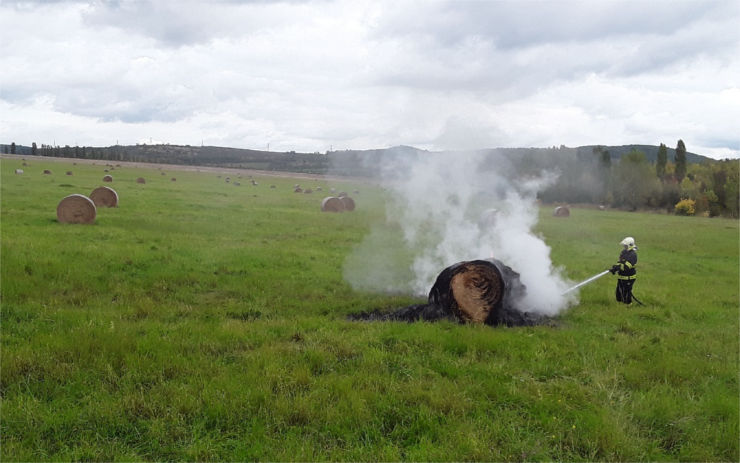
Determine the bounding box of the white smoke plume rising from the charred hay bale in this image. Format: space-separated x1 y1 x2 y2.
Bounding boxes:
344 152 577 315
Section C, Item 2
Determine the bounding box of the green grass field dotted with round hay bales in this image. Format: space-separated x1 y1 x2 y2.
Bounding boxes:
0 159 740 461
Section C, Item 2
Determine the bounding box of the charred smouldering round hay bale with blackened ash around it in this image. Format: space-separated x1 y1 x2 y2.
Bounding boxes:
350 259 547 326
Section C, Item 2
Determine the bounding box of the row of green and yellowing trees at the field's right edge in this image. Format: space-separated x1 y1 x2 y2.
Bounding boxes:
541 140 740 217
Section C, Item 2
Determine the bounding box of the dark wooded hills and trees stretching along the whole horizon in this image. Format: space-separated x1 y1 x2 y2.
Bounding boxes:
2 140 740 217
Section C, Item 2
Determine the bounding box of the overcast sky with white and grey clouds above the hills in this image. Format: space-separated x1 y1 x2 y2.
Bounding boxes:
0 0 740 158
